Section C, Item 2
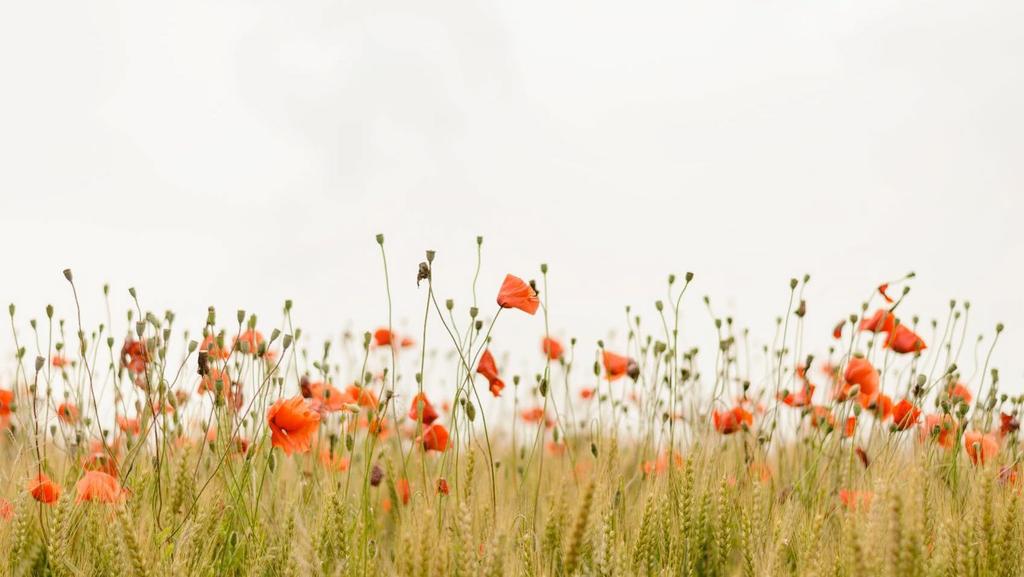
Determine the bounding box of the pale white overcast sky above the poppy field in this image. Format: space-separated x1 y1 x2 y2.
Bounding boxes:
0 0 1024 395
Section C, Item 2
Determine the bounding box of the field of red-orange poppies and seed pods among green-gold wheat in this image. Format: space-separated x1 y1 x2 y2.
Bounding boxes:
0 236 1024 577
